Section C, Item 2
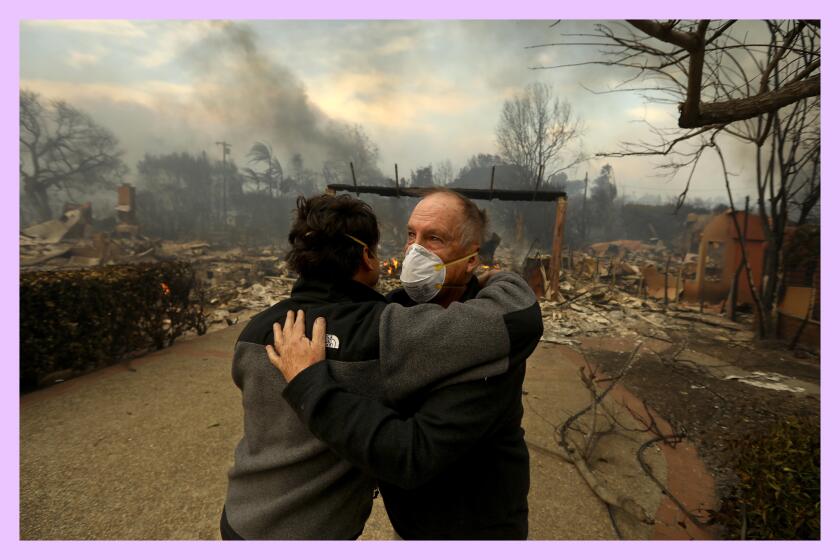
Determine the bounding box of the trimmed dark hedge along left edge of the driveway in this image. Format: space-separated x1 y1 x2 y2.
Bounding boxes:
20 262 206 390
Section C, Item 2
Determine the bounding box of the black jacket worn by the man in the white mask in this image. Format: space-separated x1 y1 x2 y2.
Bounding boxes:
284 276 542 539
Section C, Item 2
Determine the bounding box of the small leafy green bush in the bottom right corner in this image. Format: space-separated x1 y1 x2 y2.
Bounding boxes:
713 416 820 540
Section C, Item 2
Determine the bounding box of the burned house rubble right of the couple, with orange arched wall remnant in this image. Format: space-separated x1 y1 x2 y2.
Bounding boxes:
519 212 820 350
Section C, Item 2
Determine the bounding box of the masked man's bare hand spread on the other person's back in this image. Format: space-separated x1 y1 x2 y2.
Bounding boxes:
265 310 327 381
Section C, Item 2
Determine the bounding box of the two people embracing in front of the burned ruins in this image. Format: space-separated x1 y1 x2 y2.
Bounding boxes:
221 188 542 540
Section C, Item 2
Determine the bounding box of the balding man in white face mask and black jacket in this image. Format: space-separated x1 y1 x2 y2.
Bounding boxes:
268 189 542 539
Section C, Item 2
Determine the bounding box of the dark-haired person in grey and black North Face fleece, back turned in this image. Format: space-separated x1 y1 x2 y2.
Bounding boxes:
220 192 542 539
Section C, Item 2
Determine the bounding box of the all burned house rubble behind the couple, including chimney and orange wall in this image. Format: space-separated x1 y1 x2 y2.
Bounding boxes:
20 185 819 348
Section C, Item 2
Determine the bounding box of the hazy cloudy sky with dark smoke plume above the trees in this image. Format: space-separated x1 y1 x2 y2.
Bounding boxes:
20 20 768 197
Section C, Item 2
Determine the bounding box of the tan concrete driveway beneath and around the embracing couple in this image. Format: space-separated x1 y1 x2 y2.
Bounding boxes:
20 324 716 540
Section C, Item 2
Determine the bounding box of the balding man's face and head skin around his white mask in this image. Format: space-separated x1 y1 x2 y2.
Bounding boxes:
405 193 478 284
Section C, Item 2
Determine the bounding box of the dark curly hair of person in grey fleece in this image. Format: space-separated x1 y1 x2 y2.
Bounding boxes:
286 194 379 281
